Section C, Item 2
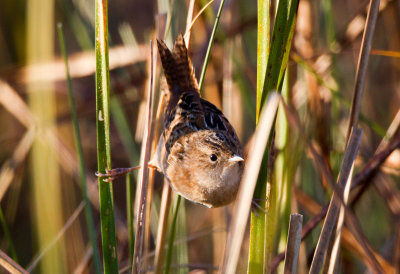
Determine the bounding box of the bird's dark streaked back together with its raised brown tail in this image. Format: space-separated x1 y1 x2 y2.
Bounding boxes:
157 34 239 156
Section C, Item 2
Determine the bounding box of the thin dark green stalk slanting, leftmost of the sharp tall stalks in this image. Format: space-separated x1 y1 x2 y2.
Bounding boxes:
57 23 101 273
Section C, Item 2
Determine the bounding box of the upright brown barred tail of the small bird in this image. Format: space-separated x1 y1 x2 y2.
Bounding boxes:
157 34 198 94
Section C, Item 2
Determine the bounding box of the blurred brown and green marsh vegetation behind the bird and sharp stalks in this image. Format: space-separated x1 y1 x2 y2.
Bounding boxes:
0 0 400 273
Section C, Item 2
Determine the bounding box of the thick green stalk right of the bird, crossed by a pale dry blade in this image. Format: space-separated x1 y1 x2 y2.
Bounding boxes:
248 0 298 273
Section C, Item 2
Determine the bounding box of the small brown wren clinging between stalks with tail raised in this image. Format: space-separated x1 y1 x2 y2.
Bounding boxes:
152 35 244 207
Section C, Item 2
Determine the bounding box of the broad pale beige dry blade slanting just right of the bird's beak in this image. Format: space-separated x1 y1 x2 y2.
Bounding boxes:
222 93 280 273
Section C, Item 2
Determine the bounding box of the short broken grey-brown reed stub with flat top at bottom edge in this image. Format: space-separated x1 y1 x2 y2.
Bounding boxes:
284 213 303 274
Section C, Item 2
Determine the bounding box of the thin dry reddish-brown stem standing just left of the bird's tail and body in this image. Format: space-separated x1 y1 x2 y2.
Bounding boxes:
132 41 154 273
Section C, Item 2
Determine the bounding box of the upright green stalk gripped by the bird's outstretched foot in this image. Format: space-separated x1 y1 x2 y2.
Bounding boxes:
96 0 118 273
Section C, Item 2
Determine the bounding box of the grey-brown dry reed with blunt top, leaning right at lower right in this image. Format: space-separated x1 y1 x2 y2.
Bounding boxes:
310 128 362 274
